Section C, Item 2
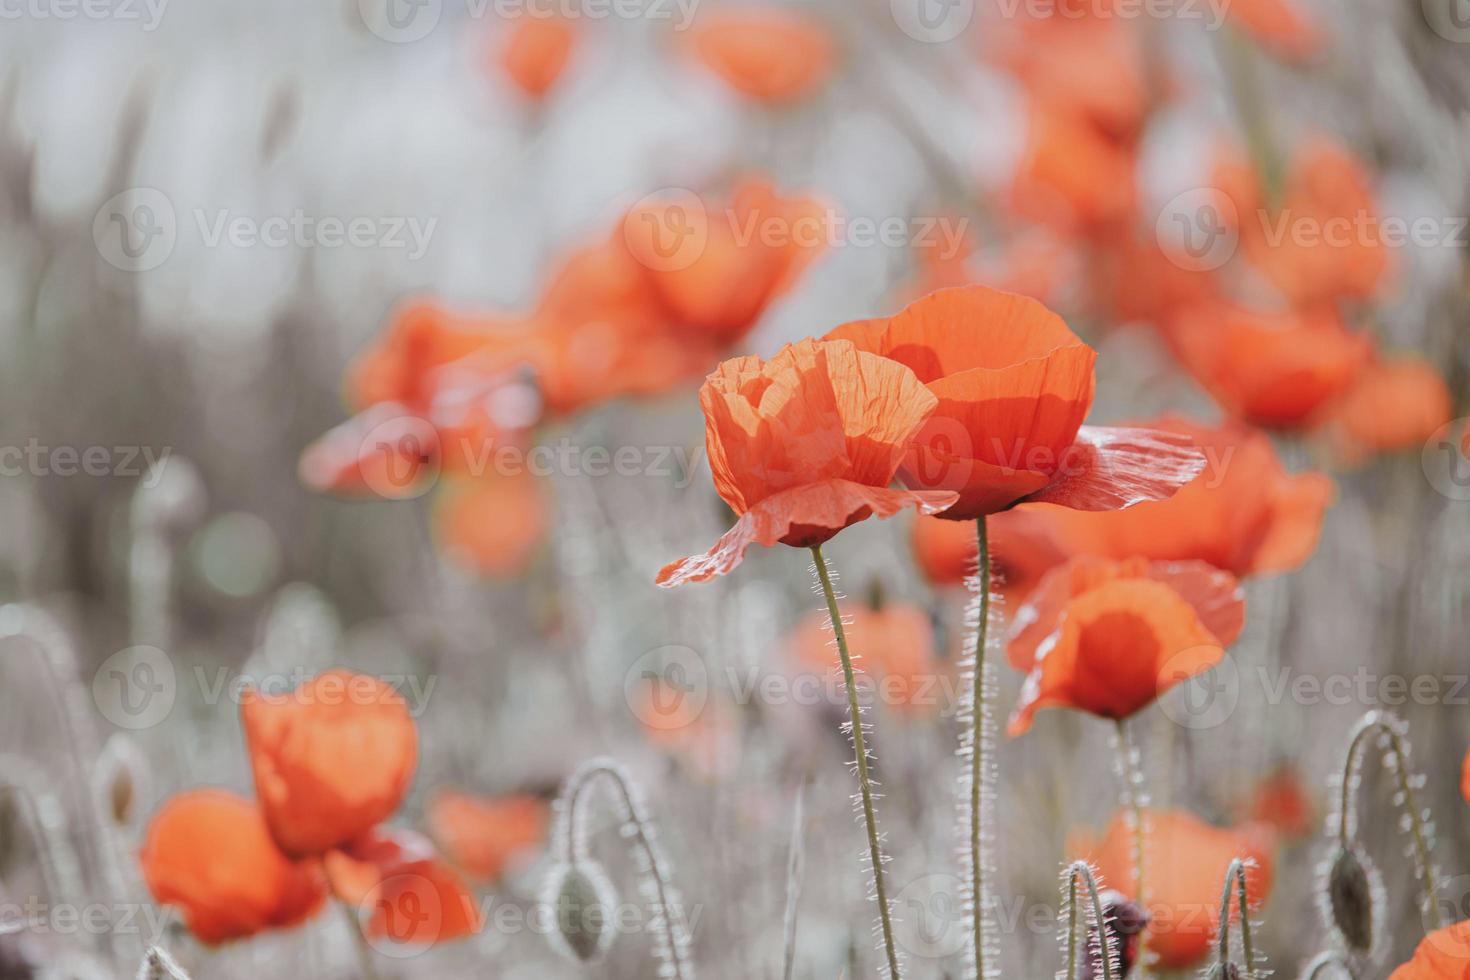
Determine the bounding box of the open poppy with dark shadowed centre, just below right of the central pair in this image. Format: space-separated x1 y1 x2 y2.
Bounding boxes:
1005 558 1245 735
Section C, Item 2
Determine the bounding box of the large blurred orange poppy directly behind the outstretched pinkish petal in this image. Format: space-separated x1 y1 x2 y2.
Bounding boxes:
994 416 1333 577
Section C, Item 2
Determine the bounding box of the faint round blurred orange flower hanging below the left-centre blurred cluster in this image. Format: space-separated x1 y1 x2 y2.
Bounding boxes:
434 470 547 577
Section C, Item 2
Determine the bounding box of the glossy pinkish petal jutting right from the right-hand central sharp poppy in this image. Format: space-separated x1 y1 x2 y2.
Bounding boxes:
1028 426 1205 510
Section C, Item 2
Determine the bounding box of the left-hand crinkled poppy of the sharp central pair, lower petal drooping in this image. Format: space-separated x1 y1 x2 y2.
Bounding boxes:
659 339 956 586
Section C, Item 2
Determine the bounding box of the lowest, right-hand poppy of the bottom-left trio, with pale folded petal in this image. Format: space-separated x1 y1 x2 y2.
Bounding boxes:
325 827 482 946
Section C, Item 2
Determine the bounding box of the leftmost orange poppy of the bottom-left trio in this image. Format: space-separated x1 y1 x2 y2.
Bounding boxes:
140 789 326 945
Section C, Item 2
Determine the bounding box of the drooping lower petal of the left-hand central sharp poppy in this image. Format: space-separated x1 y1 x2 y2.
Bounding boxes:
657 480 956 588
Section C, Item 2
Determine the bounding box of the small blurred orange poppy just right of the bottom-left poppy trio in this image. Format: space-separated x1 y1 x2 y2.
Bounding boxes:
428 789 551 882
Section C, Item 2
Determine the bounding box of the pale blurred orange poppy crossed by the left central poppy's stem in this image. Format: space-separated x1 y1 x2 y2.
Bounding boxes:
786 599 963 711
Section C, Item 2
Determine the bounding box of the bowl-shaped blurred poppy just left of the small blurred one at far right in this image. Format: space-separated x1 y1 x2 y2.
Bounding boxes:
1167 303 1372 429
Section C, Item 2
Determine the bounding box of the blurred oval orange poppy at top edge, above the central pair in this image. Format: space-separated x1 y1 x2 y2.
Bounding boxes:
692 6 836 106
